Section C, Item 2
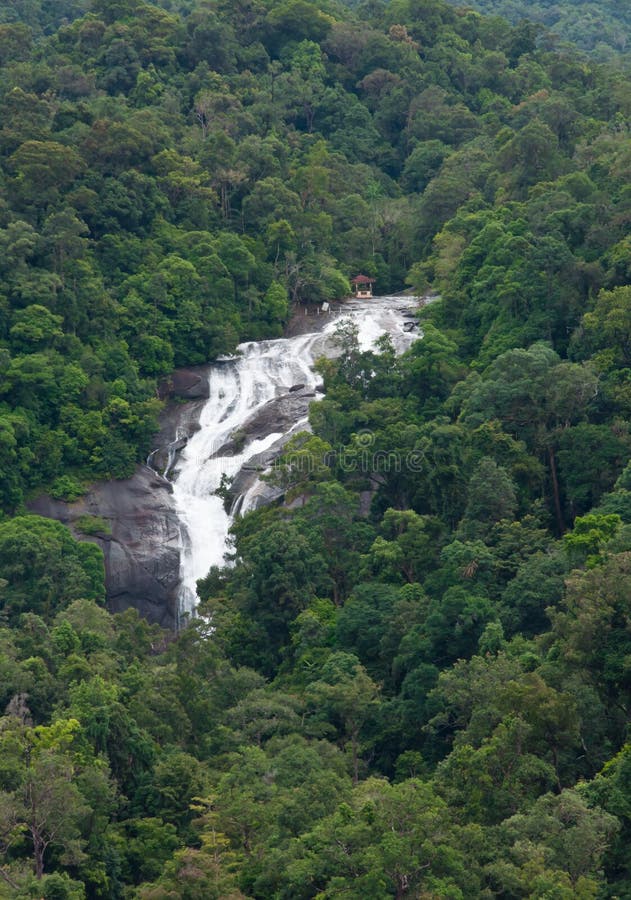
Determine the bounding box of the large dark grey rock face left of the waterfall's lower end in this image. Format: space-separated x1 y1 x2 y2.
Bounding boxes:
30 466 180 629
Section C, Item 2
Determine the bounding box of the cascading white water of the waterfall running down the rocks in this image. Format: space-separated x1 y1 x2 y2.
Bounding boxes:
173 297 417 613
